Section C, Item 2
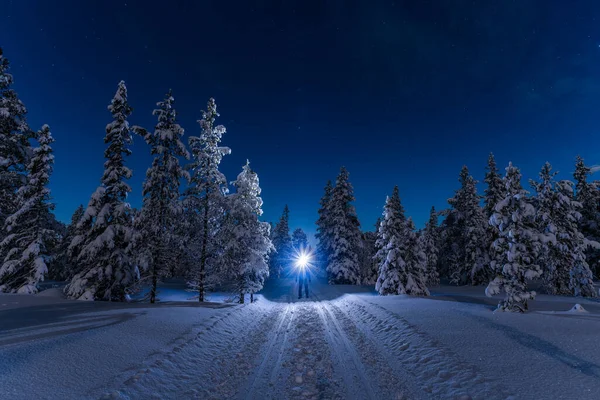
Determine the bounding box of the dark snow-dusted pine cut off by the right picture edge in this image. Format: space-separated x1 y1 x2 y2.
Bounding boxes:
573 156 600 276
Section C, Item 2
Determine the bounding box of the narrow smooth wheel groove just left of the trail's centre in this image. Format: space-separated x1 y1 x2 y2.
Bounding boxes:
240 305 294 400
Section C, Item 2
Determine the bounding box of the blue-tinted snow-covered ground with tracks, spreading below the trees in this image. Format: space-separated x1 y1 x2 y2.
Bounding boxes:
0 280 600 399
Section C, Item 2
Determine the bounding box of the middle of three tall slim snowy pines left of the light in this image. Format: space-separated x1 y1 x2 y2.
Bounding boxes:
133 90 189 303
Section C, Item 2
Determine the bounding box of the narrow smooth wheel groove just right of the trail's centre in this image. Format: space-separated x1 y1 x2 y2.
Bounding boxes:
315 302 378 400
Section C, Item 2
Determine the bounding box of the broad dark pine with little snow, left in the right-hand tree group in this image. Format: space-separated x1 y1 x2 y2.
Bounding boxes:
442 166 491 285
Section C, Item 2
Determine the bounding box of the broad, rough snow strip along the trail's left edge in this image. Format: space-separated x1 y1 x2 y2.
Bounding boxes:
102 302 281 400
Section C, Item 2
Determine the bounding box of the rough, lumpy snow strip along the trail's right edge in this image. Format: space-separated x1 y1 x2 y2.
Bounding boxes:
335 296 513 400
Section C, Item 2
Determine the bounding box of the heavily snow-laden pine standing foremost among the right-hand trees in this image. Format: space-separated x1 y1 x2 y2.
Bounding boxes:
485 163 542 312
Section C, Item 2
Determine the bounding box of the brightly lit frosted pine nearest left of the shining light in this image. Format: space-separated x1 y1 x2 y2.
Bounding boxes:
225 162 273 303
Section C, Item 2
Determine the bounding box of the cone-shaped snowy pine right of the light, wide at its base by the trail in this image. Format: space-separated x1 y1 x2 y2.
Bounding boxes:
375 186 429 296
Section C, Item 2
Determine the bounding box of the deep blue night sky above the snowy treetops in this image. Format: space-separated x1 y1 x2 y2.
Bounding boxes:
0 0 600 241
